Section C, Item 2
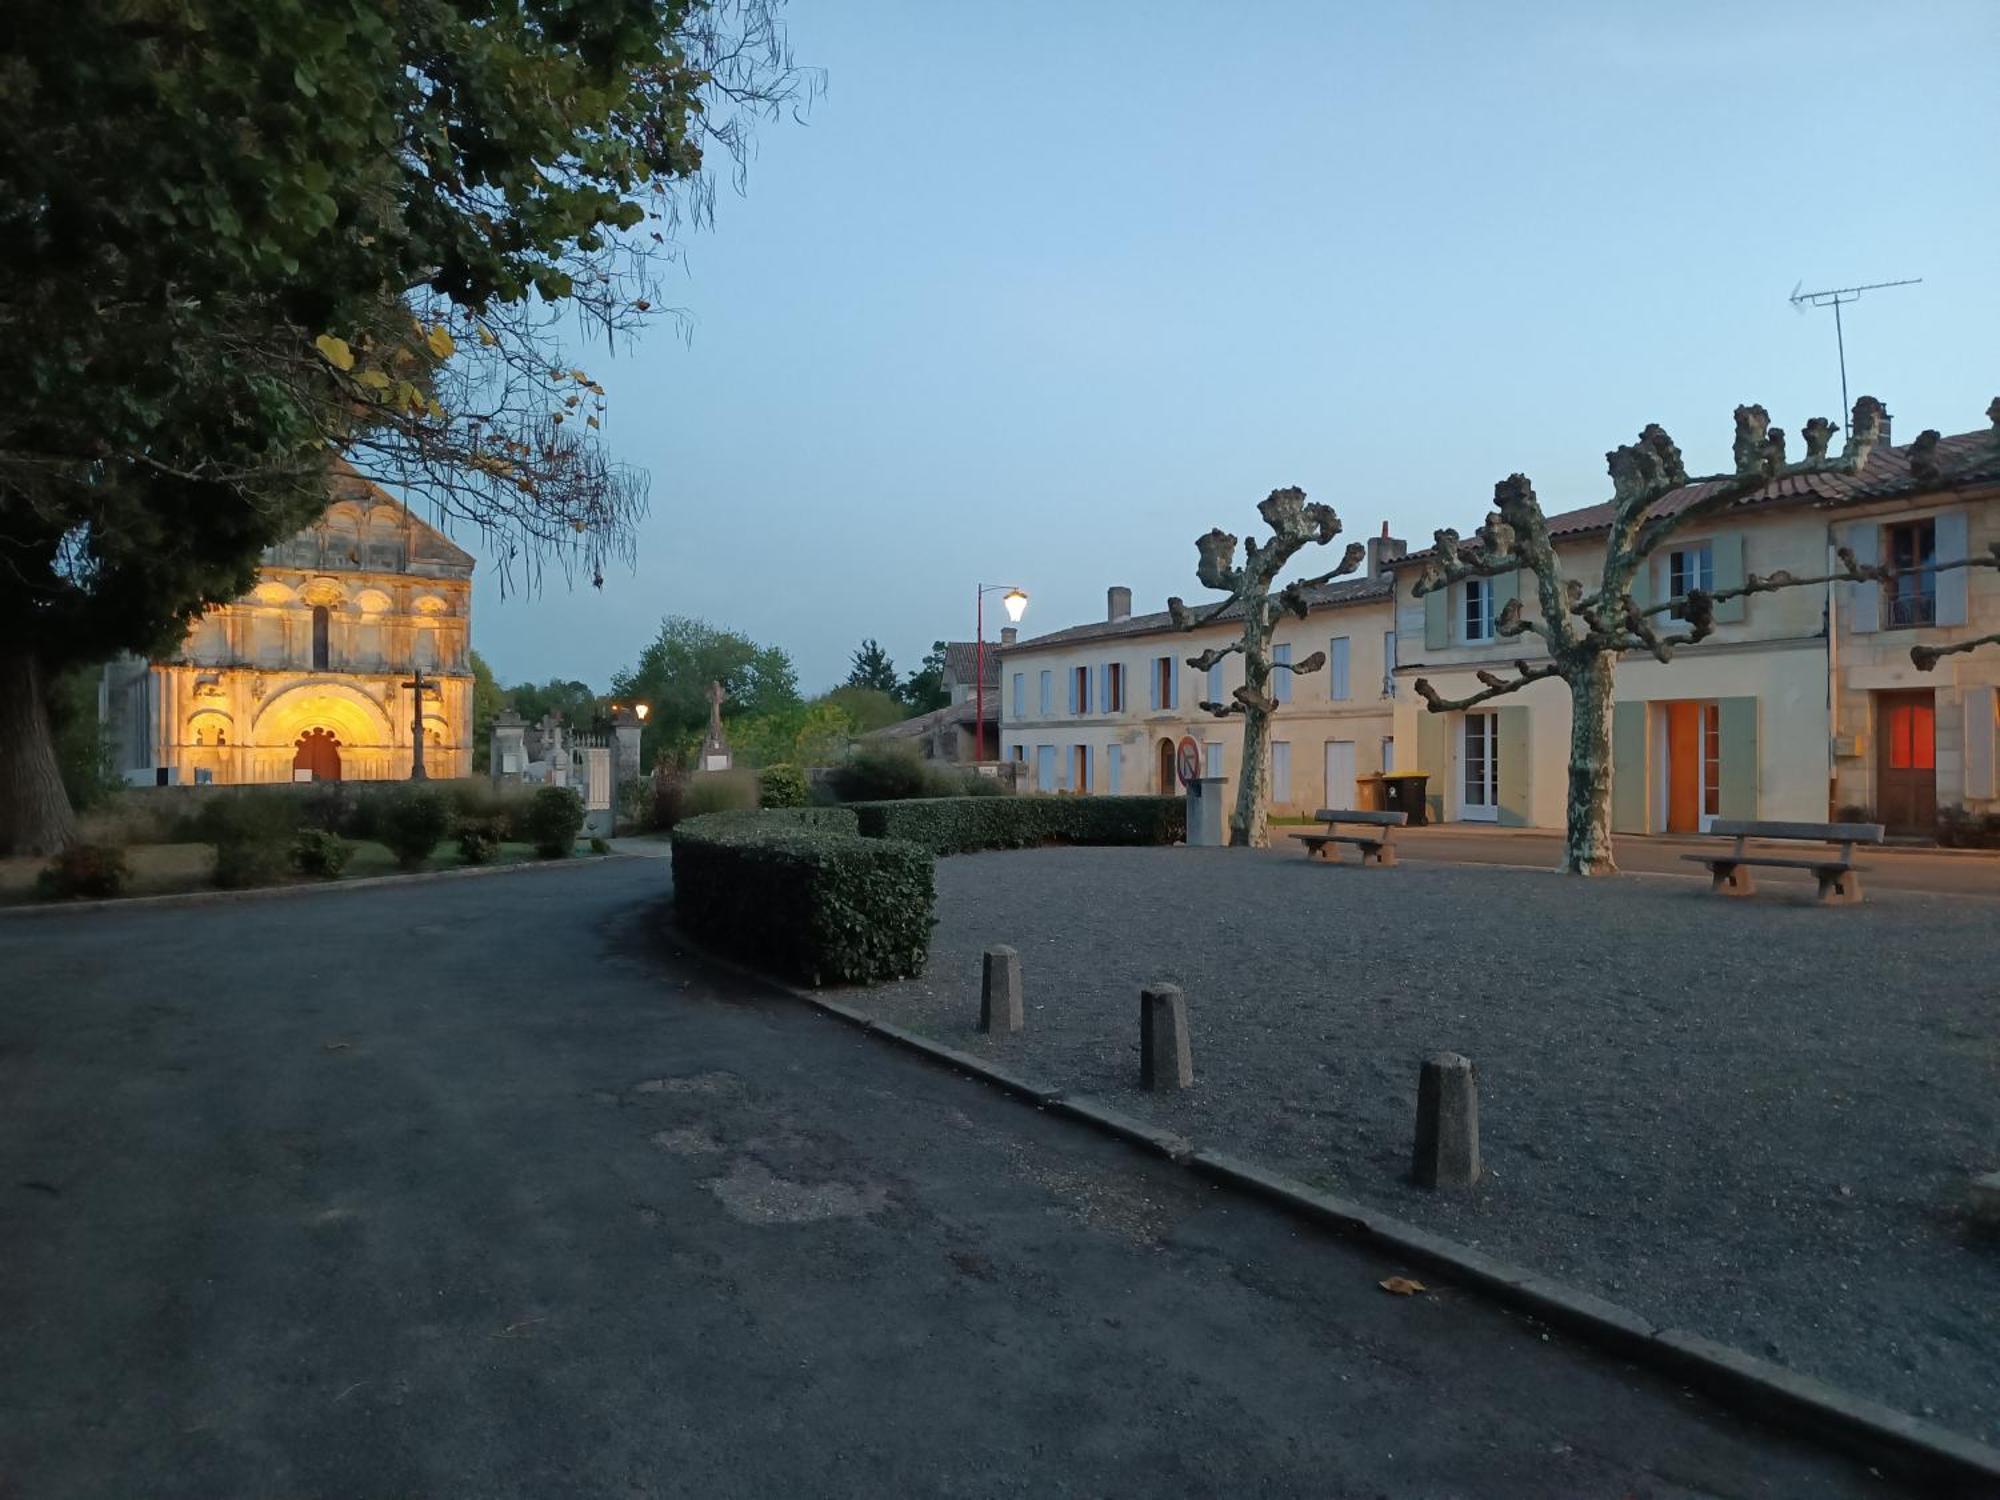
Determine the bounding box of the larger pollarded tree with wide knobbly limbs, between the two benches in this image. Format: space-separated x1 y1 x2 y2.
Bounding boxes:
1412 396 1886 876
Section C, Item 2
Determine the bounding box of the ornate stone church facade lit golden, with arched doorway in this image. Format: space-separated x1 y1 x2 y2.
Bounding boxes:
102 464 472 786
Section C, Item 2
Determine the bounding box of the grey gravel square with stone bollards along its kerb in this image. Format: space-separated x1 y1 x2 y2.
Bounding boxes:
848 848 2000 1442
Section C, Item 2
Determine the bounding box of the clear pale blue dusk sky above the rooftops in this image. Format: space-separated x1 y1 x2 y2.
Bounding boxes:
462 0 2000 692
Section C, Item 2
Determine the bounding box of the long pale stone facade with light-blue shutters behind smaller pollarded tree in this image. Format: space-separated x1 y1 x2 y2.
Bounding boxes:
1000 536 1408 814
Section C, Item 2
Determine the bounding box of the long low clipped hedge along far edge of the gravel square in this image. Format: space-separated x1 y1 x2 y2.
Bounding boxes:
850 796 1188 854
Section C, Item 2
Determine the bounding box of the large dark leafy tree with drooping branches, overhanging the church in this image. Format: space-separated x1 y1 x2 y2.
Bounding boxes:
0 0 814 852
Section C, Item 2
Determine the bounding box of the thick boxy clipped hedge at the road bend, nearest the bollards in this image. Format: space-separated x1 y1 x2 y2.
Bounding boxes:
674 808 936 984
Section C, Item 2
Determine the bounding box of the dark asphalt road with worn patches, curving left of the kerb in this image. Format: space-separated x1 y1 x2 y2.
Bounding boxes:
0 860 1892 1500
